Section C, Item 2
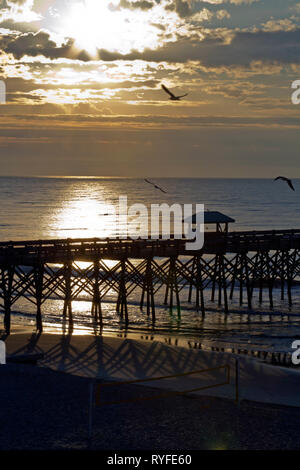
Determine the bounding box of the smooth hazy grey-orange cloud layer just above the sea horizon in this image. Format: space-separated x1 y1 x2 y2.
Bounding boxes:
0 115 300 178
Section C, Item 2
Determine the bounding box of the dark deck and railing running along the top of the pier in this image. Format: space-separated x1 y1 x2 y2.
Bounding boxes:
0 230 300 264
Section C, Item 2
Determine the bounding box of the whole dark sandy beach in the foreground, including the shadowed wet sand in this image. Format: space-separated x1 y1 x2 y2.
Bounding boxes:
0 330 300 450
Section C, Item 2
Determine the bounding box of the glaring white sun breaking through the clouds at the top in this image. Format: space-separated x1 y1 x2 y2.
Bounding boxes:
61 0 159 57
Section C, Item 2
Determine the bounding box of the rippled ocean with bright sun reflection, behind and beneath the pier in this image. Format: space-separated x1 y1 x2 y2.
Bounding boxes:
0 177 300 351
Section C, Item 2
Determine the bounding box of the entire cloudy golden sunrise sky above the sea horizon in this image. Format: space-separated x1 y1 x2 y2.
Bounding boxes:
0 0 300 177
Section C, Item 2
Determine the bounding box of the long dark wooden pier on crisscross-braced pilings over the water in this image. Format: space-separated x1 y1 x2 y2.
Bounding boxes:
0 230 300 334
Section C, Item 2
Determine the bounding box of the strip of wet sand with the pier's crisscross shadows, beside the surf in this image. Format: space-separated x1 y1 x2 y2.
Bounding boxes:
5 328 300 407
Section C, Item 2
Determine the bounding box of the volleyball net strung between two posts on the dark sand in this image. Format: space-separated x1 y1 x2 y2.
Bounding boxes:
88 358 240 446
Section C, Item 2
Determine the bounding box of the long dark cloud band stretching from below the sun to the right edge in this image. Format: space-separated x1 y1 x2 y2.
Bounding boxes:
99 29 300 67
